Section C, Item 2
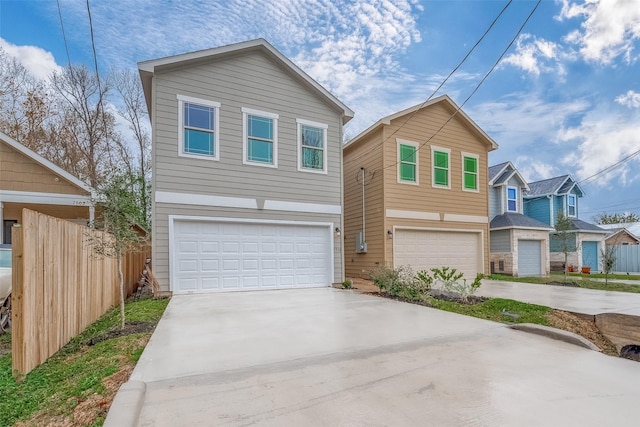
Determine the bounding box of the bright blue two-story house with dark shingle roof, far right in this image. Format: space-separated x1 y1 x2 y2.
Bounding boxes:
523 175 608 271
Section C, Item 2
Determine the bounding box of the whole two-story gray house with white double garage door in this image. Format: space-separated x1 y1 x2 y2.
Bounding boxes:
138 39 353 294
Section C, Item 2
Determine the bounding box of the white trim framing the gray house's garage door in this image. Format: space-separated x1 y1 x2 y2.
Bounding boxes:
168 215 335 292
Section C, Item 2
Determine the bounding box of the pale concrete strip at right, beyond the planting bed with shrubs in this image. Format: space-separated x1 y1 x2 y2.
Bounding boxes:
477 279 640 316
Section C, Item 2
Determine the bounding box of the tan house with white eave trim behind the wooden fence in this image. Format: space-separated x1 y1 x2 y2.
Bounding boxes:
0 132 94 244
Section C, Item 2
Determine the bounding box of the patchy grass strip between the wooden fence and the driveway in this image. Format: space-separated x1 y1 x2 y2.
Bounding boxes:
0 299 169 426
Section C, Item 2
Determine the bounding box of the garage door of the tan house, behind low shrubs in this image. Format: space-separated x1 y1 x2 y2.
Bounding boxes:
393 229 484 279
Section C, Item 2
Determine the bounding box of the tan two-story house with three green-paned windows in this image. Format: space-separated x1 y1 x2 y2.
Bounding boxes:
343 95 498 278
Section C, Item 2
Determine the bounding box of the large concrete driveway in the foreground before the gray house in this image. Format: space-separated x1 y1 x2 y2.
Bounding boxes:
106 288 640 426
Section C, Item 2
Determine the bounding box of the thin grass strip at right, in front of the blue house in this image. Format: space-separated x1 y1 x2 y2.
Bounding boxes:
487 272 640 294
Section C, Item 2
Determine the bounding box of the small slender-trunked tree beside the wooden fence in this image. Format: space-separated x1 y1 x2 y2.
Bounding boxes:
89 173 147 329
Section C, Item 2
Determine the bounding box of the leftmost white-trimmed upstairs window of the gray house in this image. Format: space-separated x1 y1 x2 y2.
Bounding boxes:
177 95 220 160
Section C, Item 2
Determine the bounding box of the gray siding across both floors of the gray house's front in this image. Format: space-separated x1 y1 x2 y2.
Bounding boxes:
152 51 343 289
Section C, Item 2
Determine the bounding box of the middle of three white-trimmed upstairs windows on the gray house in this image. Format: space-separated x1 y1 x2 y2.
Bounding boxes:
242 108 279 168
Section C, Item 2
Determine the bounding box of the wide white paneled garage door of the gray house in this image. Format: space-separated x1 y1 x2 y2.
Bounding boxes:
172 220 333 293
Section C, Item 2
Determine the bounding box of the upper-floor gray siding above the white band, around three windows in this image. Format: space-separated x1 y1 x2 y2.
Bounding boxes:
154 53 342 204
